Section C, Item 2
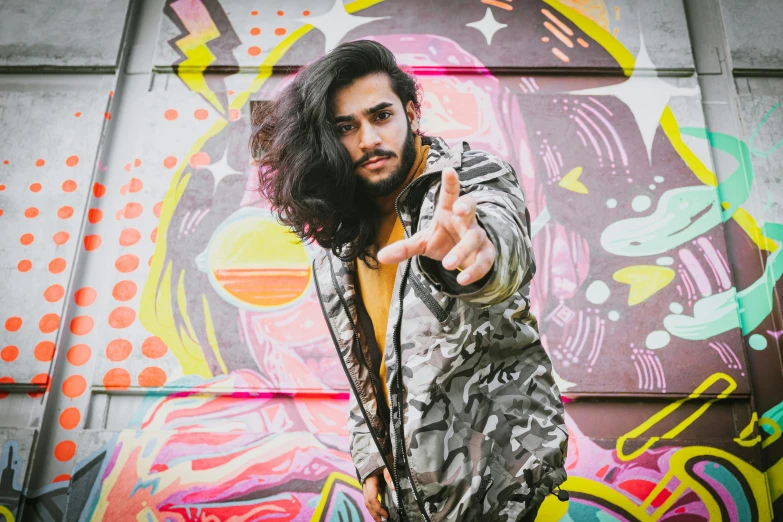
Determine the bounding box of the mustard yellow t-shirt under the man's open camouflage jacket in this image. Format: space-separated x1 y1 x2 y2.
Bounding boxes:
356 136 430 404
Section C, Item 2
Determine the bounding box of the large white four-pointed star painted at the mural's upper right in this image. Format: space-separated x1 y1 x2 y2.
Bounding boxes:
571 34 699 159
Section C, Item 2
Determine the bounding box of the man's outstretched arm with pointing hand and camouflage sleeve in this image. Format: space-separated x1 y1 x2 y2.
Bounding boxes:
378 163 535 306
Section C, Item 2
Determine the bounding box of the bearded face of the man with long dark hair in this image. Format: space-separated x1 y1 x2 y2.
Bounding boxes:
334 73 418 197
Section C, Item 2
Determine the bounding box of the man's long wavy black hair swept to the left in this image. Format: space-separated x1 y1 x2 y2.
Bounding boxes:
250 40 421 263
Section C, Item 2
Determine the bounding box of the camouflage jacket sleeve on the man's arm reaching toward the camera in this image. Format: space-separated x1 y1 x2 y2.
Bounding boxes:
417 155 536 307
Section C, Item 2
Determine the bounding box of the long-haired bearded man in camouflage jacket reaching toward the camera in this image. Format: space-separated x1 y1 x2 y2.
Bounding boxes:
251 41 568 521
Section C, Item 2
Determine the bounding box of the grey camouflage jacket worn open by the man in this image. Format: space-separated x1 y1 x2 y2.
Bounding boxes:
313 137 568 522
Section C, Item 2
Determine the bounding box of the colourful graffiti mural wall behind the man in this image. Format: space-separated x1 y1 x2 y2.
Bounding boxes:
0 0 783 522
